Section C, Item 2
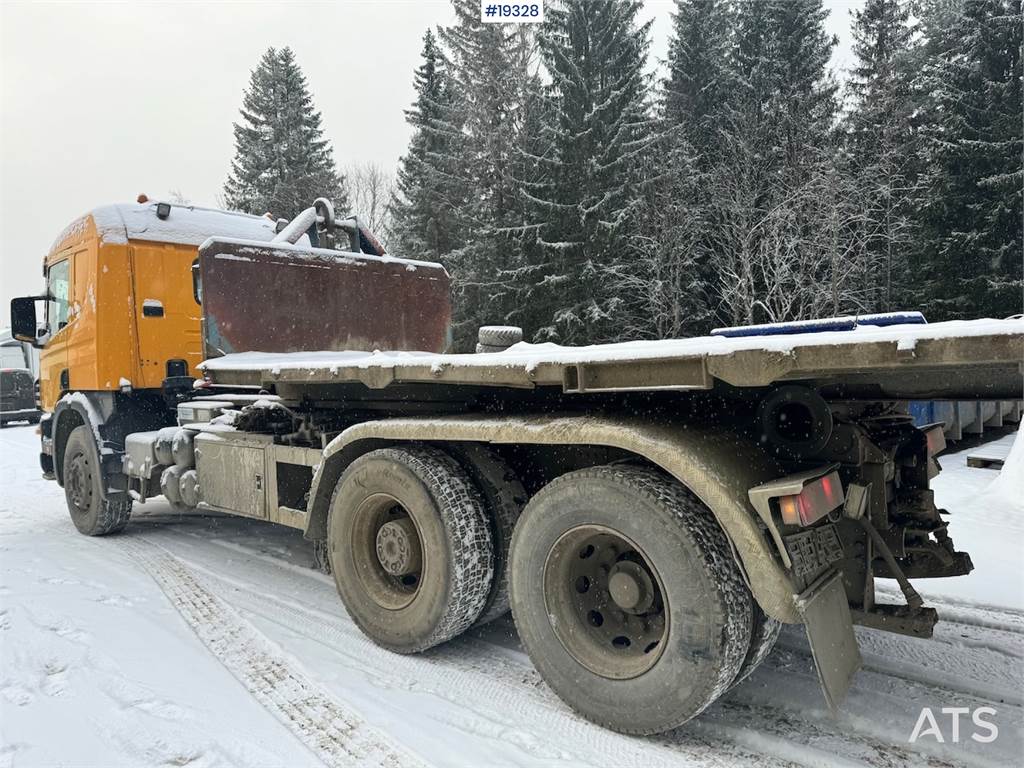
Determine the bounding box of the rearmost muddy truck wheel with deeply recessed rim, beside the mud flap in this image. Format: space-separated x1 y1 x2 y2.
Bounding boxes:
511 466 753 734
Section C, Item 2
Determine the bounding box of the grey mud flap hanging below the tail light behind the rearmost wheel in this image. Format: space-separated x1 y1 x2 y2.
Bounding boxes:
797 570 861 715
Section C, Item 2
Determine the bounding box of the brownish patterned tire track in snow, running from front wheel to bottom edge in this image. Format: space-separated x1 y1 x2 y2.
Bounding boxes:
118 537 425 768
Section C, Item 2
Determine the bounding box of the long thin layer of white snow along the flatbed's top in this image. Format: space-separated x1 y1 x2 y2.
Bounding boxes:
202 319 1024 373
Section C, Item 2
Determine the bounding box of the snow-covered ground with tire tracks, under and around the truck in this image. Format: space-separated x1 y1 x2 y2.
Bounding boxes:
0 426 1024 768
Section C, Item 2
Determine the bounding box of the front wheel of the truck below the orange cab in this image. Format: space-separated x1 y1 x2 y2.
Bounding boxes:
63 424 131 536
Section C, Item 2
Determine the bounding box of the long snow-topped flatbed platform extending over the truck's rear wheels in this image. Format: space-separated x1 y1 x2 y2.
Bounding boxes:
201 319 1024 399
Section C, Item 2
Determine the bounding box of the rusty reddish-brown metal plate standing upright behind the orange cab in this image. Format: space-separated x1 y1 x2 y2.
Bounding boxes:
199 240 452 359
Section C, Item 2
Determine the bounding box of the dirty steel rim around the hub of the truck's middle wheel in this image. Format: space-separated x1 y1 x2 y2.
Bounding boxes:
350 494 427 610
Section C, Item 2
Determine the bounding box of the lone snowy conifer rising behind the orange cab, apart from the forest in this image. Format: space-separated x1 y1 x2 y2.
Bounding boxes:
224 48 348 218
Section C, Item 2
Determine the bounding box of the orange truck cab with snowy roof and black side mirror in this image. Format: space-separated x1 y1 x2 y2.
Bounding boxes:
11 201 275 498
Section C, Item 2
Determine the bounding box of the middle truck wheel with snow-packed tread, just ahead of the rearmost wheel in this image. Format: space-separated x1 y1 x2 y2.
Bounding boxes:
328 446 494 653
